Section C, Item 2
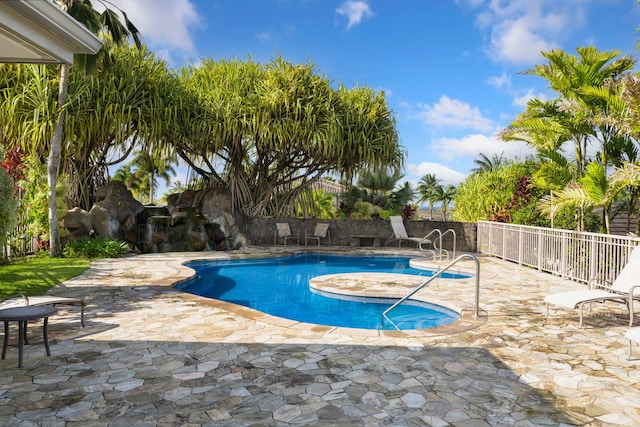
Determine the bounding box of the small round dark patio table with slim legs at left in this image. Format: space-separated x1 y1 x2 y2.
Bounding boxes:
0 305 58 368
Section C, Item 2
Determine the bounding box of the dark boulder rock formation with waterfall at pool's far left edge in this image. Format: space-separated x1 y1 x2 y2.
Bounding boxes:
63 181 246 253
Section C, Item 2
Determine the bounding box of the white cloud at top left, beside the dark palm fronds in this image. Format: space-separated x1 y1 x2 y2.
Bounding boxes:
101 0 204 55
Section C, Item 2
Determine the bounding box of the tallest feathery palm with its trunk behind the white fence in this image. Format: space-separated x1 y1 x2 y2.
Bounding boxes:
500 47 635 231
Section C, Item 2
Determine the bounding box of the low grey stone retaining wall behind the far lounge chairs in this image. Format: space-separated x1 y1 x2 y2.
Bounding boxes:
238 218 477 252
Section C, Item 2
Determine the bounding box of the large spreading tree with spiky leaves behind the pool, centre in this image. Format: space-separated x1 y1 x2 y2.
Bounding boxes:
175 58 403 217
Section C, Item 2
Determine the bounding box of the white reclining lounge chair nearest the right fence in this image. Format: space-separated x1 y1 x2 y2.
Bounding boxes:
544 246 640 327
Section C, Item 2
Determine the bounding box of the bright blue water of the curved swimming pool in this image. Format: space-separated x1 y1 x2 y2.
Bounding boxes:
176 253 468 330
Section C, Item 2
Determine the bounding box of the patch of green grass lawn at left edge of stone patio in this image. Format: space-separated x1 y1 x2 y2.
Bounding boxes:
0 257 90 299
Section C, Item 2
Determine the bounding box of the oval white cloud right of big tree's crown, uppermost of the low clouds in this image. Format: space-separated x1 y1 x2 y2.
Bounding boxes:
417 95 494 132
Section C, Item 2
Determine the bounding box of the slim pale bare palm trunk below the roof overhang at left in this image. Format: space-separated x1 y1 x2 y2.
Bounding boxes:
47 64 71 257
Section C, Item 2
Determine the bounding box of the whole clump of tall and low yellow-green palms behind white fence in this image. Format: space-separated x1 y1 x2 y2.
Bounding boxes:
501 47 639 232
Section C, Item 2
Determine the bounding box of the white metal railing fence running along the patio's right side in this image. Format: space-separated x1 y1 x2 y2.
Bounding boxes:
477 221 640 282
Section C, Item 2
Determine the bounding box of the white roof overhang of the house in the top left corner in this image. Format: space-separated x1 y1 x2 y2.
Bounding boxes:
0 0 102 64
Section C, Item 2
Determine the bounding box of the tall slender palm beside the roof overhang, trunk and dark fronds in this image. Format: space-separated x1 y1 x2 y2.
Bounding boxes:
47 0 142 257
